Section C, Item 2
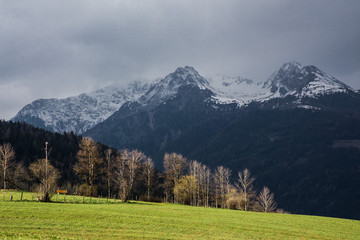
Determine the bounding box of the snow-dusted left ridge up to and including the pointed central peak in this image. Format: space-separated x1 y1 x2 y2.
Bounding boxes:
12 66 214 134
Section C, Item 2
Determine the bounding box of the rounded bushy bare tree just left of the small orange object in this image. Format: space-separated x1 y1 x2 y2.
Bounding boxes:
29 159 60 202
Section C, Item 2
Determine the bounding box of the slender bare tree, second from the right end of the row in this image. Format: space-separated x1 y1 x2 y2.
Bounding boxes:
236 168 256 211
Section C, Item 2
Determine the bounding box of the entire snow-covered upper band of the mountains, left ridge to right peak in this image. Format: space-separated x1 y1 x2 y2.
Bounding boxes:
12 61 355 134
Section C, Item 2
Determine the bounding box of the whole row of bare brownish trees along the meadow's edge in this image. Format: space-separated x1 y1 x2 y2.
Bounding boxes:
0 138 281 212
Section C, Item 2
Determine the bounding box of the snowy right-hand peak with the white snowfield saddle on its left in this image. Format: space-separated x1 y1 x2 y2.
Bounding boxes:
210 61 354 106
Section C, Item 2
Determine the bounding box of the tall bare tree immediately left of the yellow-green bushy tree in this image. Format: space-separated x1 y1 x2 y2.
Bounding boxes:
164 153 187 202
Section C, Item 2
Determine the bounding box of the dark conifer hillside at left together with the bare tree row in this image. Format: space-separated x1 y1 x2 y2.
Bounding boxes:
0 121 283 212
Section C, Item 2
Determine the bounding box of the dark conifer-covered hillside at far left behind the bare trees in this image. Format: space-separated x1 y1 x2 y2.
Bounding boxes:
0 121 81 187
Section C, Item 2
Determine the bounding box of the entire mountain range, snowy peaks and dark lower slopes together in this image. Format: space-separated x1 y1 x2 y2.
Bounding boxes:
13 62 360 219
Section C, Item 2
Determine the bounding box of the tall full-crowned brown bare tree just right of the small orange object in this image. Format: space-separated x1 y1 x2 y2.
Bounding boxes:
74 138 103 195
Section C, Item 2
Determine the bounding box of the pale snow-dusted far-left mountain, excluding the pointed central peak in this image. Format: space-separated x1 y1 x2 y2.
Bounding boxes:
12 82 151 134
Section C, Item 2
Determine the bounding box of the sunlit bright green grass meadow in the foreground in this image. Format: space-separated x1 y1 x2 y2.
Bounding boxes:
0 192 360 239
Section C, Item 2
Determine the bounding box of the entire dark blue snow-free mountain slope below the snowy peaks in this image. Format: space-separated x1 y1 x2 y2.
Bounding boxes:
87 91 360 219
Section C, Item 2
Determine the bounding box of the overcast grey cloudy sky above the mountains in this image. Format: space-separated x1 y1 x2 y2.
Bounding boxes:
0 0 360 120
